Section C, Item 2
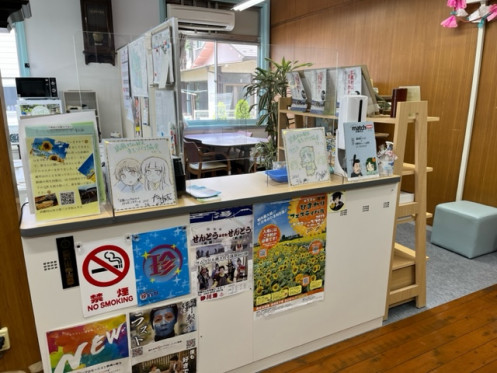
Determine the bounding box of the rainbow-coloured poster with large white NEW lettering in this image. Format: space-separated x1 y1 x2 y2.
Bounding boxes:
47 315 129 373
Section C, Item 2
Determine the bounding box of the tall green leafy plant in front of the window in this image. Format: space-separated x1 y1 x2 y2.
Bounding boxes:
244 57 311 169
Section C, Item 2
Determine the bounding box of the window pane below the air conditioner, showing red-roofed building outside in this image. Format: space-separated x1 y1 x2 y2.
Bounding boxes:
180 36 259 124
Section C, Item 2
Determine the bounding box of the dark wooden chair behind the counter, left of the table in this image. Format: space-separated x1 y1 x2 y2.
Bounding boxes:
183 141 231 178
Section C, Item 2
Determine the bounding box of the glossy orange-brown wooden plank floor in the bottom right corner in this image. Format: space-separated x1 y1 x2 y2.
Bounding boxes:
264 285 497 373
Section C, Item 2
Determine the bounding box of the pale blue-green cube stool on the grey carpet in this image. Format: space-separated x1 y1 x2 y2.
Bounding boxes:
431 201 497 259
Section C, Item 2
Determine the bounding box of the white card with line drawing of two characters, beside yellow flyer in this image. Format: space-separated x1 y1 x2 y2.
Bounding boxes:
104 138 176 212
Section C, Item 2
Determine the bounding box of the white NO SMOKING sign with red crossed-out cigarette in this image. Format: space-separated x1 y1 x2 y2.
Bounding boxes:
76 237 137 317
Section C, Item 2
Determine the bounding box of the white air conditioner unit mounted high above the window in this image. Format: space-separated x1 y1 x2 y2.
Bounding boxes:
167 4 235 31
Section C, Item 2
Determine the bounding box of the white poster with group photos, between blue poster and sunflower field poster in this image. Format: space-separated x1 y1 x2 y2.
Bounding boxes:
189 206 254 301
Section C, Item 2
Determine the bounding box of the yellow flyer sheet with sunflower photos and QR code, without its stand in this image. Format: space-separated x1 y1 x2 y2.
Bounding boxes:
26 135 100 221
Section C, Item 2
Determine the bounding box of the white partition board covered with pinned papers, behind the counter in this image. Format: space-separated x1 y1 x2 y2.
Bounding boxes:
117 18 183 155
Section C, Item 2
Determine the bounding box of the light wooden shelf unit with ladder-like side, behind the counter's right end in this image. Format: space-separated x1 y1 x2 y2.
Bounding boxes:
278 97 439 318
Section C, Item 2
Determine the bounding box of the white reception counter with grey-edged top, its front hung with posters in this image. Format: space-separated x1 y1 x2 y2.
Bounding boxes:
21 173 399 373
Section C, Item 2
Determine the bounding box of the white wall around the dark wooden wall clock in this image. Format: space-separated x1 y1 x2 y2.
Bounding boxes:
25 0 159 138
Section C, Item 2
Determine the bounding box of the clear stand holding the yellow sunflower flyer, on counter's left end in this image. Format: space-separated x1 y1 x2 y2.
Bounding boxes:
19 113 105 221
